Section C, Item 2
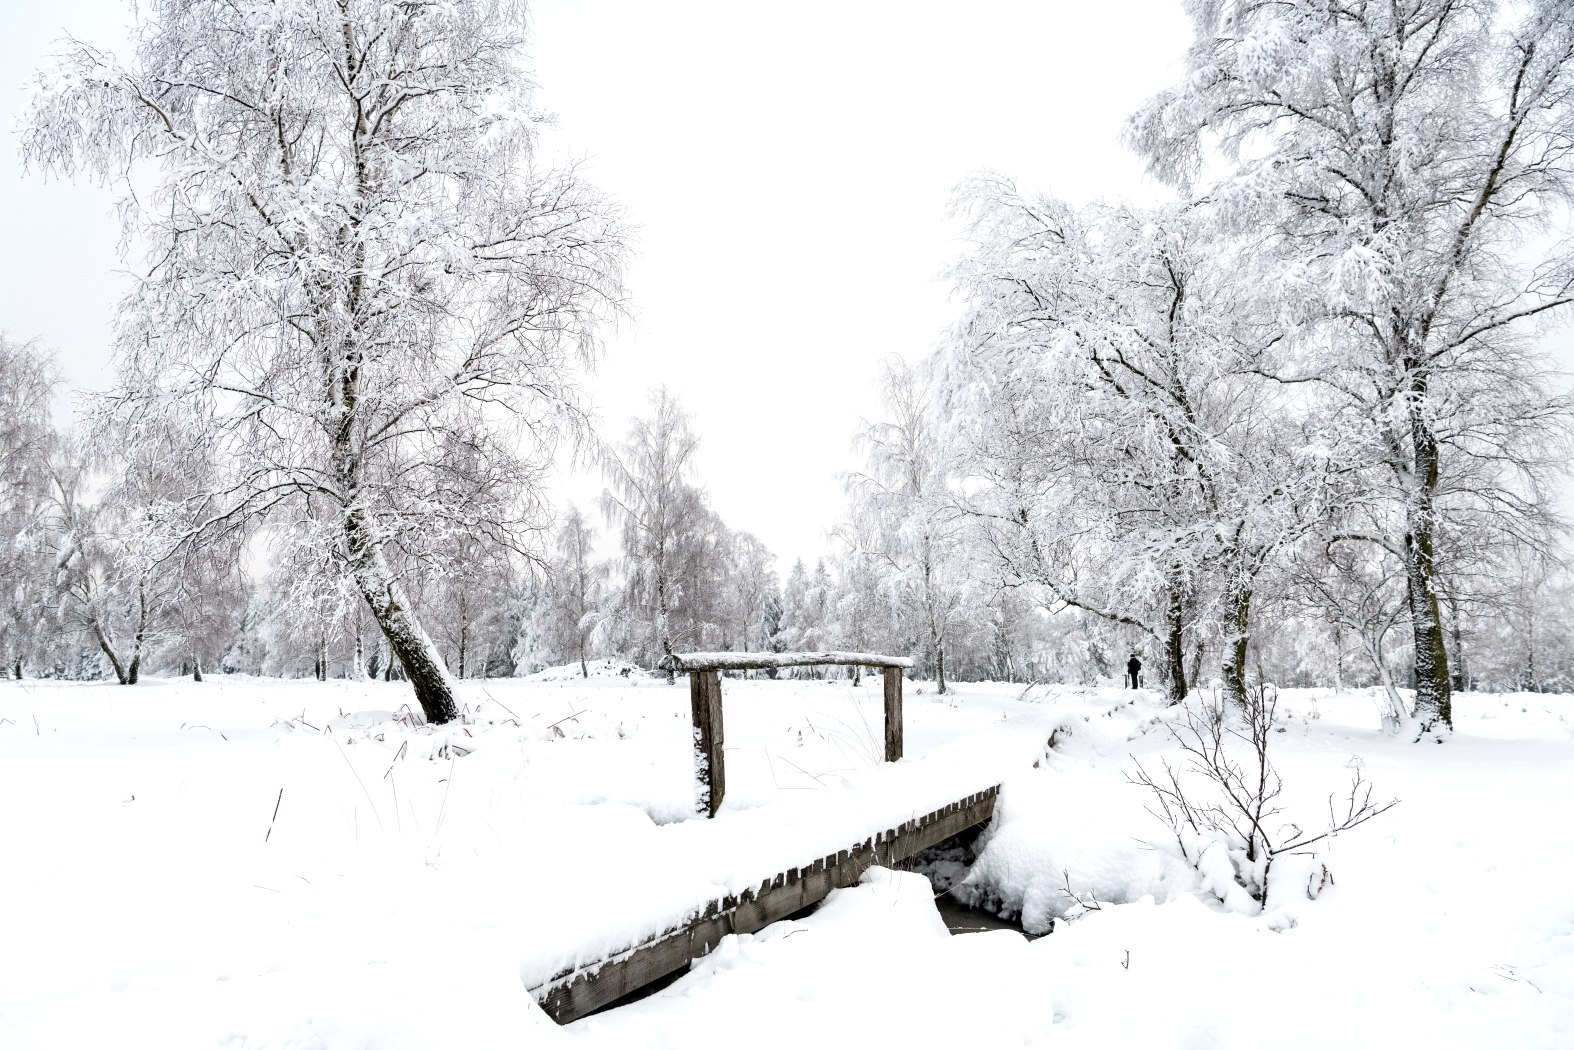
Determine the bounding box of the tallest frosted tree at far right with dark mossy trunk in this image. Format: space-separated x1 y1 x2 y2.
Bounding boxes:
1129 0 1574 732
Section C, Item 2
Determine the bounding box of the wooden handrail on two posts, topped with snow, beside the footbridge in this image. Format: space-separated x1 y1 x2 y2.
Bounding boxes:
656 653 913 817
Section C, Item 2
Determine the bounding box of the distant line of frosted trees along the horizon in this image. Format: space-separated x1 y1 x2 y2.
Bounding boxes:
9 340 1574 714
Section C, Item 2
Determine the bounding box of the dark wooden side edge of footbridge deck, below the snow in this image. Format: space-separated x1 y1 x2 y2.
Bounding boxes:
530 787 998 1023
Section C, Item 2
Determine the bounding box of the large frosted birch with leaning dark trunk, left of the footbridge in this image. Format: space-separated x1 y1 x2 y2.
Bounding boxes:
20 0 625 723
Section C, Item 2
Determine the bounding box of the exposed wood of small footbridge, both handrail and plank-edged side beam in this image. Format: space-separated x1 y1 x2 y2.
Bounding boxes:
530 652 998 1023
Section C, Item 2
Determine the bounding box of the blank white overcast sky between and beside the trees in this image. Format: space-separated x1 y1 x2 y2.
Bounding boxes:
0 0 1188 573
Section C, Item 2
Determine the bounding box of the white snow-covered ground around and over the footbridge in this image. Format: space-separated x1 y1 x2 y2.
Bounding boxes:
0 667 1574 1050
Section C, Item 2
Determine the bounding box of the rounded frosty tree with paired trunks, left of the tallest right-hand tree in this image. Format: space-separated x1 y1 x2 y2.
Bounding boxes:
943 186 1328 702
